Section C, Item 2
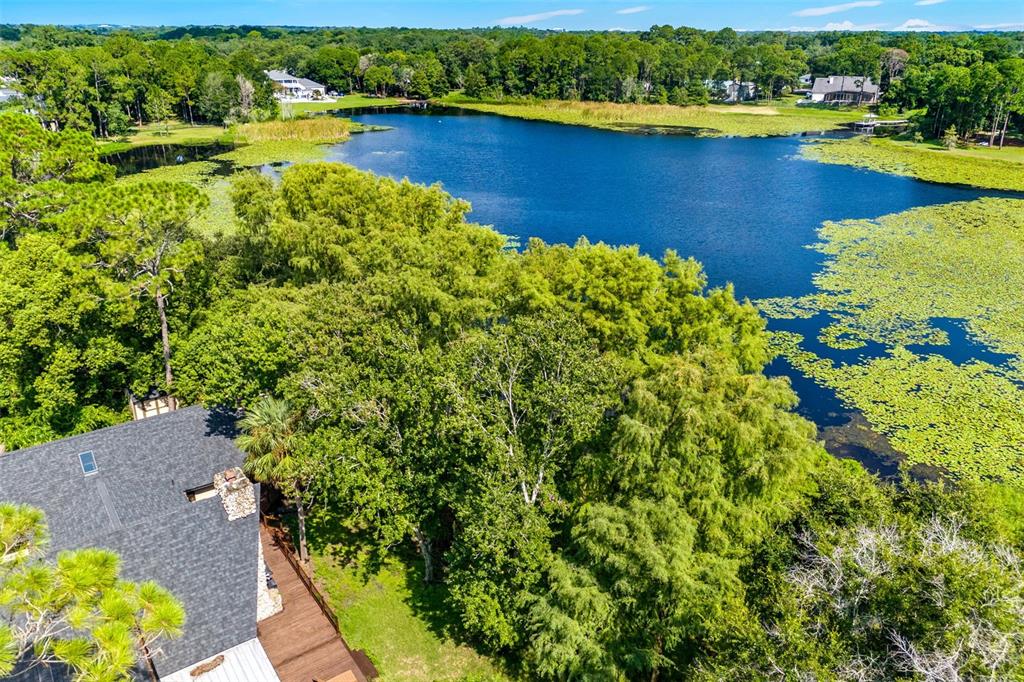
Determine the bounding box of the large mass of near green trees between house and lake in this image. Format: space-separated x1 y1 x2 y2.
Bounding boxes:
6 114 1024 680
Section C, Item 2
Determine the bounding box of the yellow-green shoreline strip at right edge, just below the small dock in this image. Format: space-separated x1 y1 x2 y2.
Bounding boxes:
803 136 1024 191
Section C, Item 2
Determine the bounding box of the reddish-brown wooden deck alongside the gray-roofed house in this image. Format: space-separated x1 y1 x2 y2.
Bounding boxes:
256 527 367 682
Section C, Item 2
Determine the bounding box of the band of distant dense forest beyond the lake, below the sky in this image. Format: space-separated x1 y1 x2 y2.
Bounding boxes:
0 26 1024 138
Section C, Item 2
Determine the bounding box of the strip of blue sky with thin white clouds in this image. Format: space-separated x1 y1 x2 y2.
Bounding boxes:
0 0 1024 31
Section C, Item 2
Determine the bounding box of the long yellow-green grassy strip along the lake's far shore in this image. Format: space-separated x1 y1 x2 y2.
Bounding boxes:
438 95 864 137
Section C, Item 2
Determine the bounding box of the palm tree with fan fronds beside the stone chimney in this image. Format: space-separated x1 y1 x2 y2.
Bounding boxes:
238 396 309 563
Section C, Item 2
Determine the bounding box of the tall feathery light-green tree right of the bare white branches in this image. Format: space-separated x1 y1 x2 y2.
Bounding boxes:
528 351 823 679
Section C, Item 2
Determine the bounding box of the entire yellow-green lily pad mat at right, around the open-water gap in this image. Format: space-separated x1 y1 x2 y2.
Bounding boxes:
759 199 1024 484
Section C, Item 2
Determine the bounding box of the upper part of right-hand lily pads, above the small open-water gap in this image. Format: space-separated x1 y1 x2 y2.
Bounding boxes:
759 199 1024 367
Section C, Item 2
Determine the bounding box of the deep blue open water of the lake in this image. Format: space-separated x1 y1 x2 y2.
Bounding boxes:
331 110 998 466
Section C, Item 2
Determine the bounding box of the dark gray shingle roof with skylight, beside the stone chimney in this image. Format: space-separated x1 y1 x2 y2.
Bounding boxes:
0 407 259 675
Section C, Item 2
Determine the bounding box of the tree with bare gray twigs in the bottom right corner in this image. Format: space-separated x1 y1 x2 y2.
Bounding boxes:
733 514 1024 679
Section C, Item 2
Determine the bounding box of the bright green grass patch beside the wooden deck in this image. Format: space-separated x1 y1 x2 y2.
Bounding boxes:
312 544 511 682
